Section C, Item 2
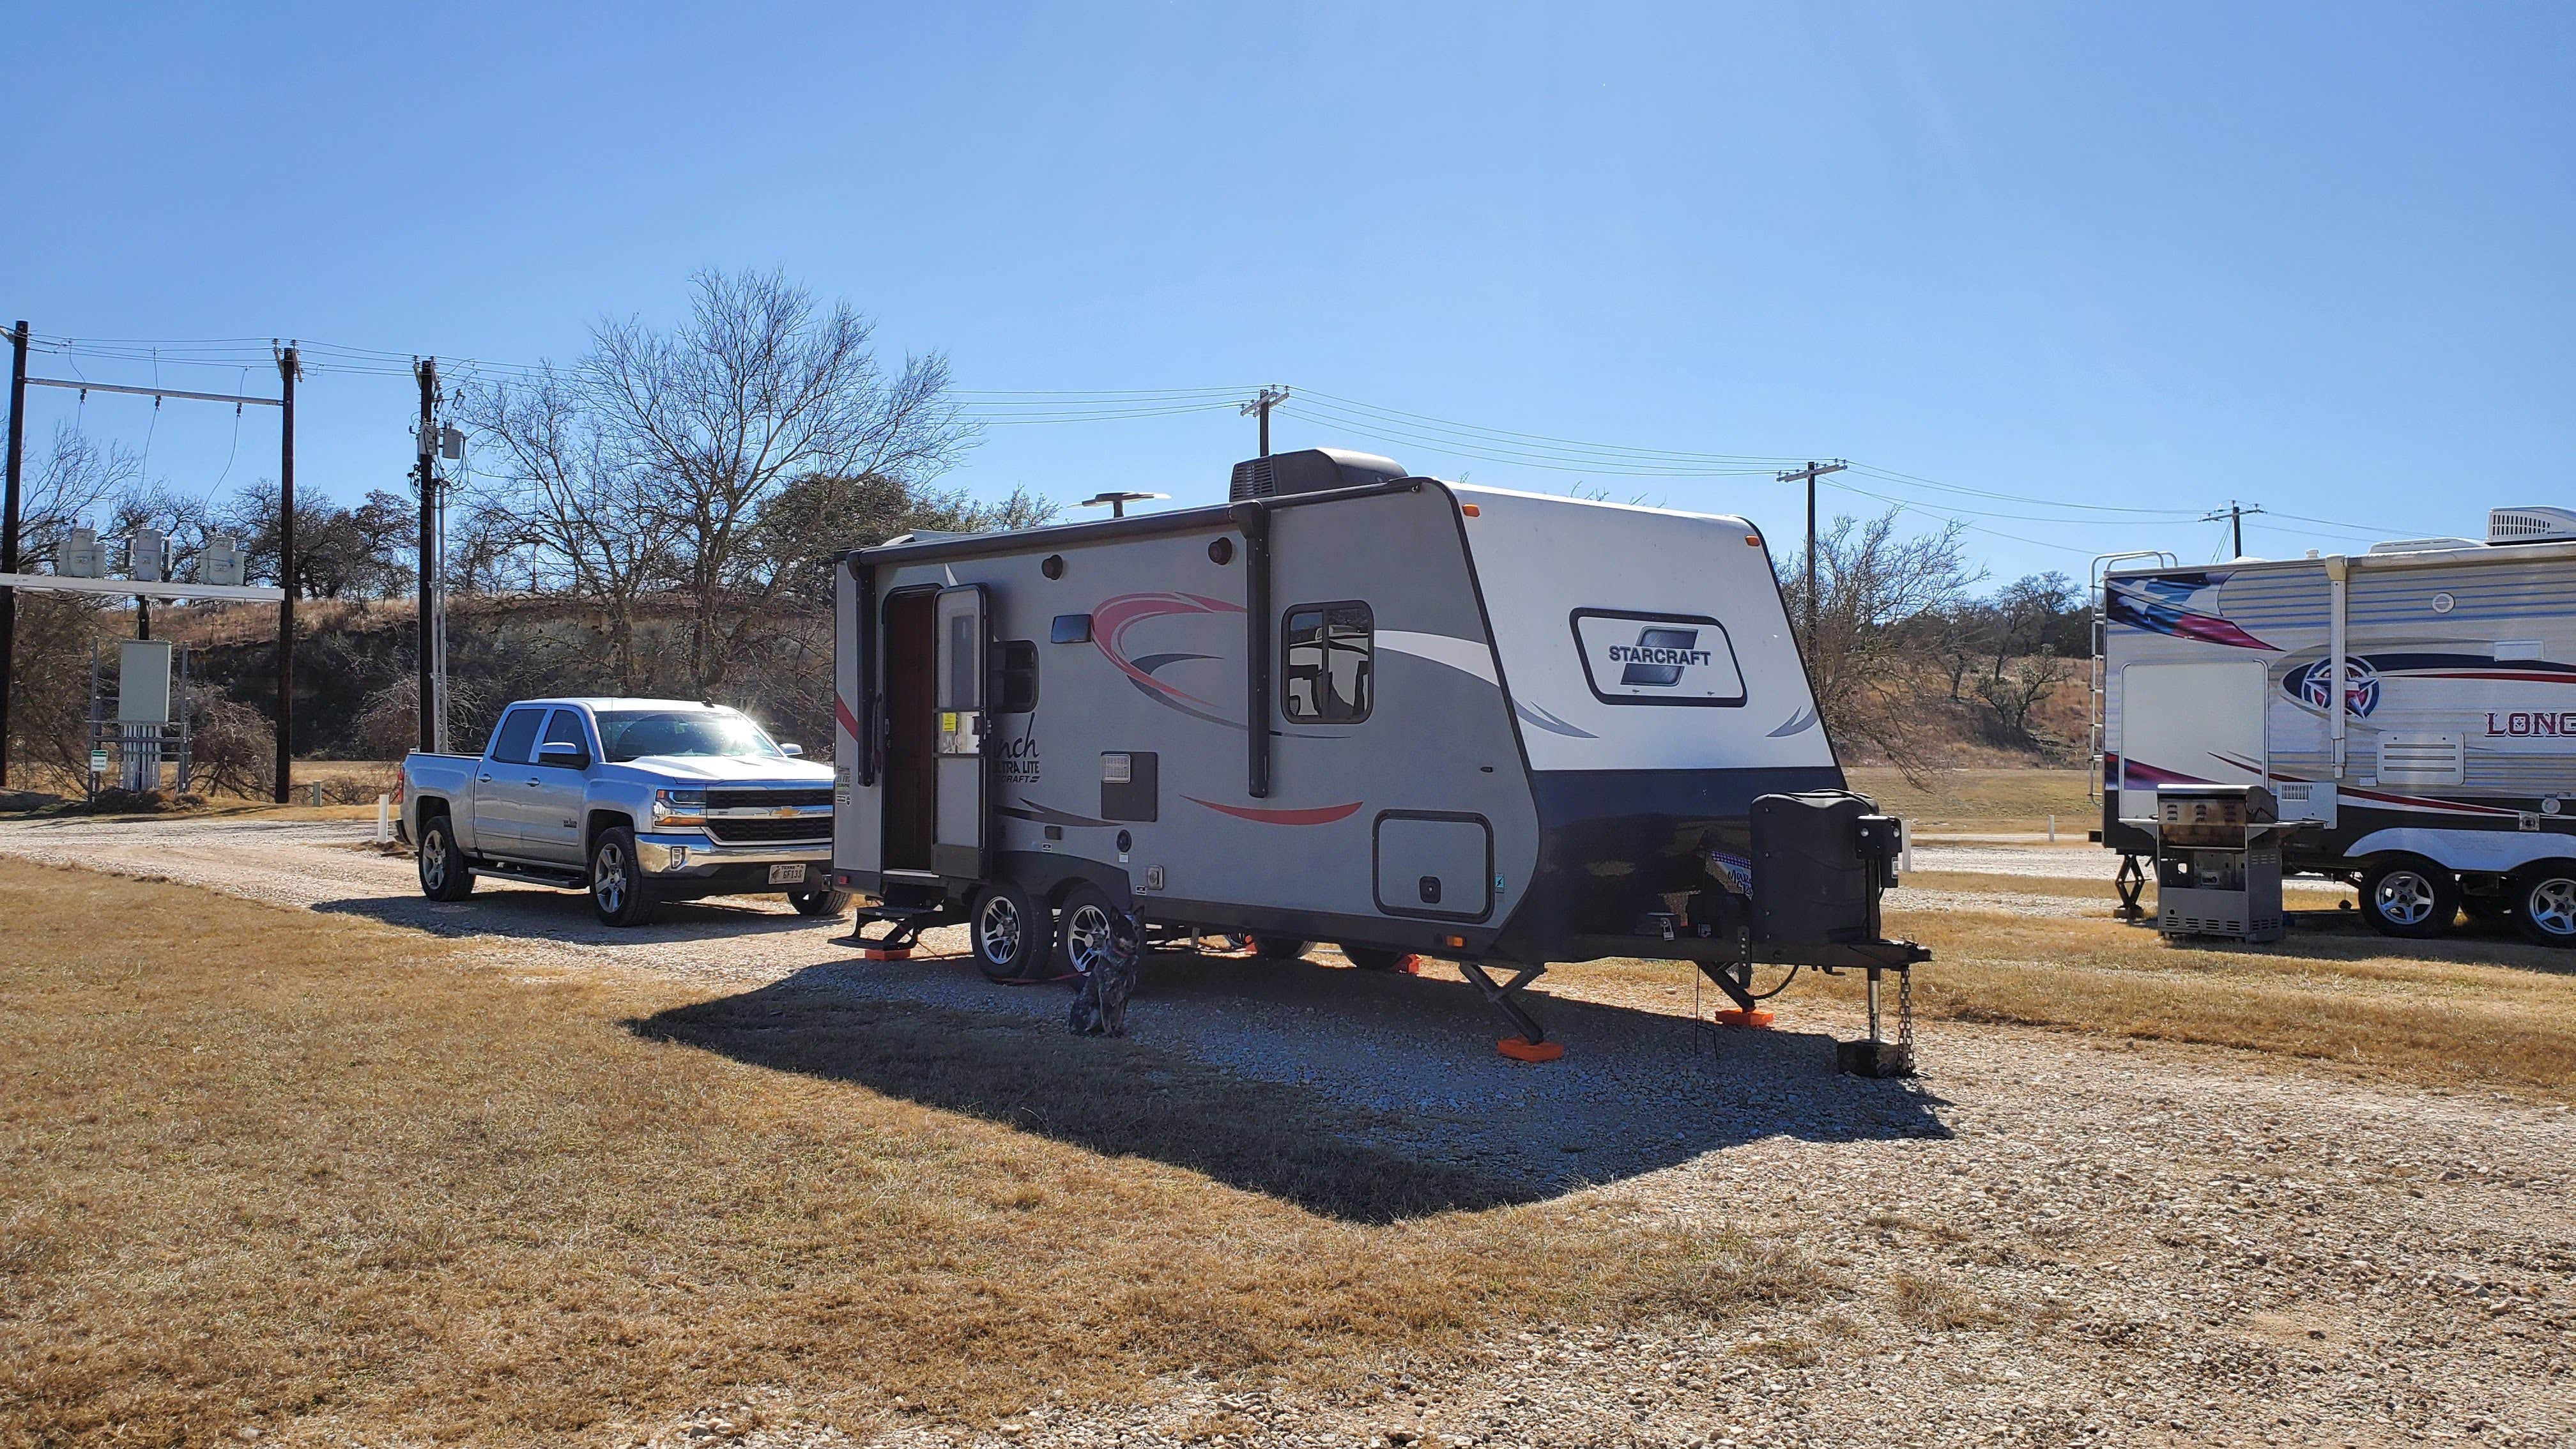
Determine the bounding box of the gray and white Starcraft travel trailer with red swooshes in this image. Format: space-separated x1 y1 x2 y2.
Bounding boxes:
832 448 1922 1041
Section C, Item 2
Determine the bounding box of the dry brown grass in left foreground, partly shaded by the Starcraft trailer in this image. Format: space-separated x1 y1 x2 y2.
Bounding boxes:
0 861 1819 1444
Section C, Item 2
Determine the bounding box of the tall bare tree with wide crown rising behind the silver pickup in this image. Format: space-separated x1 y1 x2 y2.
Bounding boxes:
579 271 974 694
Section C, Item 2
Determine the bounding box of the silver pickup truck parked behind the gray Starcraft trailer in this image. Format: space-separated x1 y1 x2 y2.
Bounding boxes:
402 699 850 926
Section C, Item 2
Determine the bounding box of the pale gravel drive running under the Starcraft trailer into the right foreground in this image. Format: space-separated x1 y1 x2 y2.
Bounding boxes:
0 820 2576 1446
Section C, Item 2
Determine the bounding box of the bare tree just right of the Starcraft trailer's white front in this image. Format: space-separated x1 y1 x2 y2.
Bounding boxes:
1782 508 1984 776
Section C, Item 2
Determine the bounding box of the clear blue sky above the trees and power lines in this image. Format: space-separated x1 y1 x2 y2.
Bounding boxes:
0 5 2576 578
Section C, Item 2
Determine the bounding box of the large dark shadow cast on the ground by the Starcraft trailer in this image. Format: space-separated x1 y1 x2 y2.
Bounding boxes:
629 954 1950 1222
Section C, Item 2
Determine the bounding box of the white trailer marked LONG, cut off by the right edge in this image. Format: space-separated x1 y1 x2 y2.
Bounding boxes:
2099 508 2576 946
